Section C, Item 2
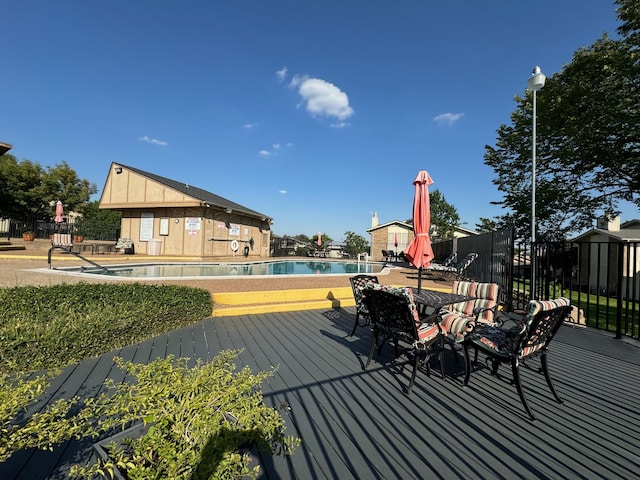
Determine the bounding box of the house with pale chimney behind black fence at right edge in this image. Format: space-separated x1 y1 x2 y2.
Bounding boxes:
572 217 640 299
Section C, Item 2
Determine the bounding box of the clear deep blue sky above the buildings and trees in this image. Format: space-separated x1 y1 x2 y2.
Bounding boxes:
0 0 637 241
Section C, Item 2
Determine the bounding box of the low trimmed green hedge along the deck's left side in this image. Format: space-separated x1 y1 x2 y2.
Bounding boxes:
0 283 213 373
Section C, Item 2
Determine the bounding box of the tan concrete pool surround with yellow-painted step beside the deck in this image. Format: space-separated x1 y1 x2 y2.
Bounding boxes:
0 239 451 316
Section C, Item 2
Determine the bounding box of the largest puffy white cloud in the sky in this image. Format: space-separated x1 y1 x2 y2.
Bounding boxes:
289 75 354 128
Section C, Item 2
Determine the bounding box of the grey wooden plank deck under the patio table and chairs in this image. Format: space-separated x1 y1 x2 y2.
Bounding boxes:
0 308 640 480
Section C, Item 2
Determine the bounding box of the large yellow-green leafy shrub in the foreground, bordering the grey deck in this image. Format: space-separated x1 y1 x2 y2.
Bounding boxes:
71 350 300 480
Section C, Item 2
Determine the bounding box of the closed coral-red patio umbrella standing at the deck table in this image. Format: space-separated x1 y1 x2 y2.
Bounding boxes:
404 170 433 292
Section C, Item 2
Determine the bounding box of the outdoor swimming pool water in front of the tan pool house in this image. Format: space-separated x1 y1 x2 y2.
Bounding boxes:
60 260 385 279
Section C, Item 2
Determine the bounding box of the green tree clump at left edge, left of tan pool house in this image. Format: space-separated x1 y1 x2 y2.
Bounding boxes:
0 153 97 219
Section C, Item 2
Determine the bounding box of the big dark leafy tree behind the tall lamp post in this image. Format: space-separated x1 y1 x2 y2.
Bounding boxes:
485 19 640 240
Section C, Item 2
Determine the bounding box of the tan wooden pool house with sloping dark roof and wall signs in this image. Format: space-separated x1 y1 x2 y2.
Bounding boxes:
99 163 273 257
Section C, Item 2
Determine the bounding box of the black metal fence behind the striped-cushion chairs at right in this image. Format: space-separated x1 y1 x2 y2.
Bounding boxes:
434 230 640 339
